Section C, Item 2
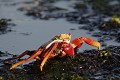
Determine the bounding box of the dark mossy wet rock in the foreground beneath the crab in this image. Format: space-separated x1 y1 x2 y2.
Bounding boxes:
0 46 120 80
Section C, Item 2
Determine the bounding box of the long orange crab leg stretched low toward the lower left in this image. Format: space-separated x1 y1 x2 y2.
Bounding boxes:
10 49 42 70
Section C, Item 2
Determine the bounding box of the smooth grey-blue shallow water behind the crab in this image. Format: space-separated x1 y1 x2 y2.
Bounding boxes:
0 0 117 54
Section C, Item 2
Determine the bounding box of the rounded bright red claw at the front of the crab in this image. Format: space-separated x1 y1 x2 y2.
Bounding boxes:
62 42 74 56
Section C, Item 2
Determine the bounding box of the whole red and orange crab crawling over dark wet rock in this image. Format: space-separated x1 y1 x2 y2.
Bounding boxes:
5 33 100 71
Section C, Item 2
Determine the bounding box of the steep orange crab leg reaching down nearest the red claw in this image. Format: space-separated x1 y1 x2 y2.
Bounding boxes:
40 43 58 71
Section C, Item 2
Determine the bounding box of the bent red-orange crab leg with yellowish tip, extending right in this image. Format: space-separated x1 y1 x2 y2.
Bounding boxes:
71 37 101 50
